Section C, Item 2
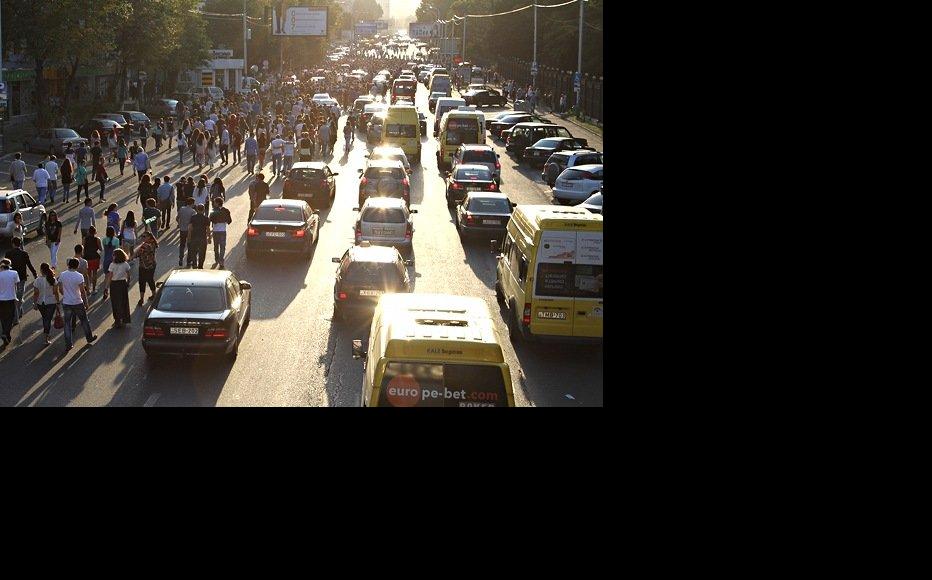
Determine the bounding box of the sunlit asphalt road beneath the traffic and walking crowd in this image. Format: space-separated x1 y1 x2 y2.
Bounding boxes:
0 86 602 406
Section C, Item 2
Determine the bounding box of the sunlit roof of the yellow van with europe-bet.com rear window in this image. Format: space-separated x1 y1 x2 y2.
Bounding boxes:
379 293 505 363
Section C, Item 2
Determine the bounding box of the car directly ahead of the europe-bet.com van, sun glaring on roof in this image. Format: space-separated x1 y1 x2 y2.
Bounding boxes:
332 242 414 320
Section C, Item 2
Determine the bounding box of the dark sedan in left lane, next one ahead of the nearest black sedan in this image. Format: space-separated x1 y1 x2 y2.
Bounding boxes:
246 199 320 258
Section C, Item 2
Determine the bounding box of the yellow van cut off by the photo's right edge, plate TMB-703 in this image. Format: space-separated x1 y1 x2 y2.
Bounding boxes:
492 204 602 342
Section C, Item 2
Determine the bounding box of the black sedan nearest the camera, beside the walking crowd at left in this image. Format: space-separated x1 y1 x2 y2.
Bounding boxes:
142 270 252 359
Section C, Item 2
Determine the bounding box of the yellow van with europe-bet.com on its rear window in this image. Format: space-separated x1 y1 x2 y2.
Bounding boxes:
353 293 515 407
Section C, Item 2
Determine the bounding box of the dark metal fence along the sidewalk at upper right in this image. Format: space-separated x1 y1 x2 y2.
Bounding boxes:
497 58 604 124
